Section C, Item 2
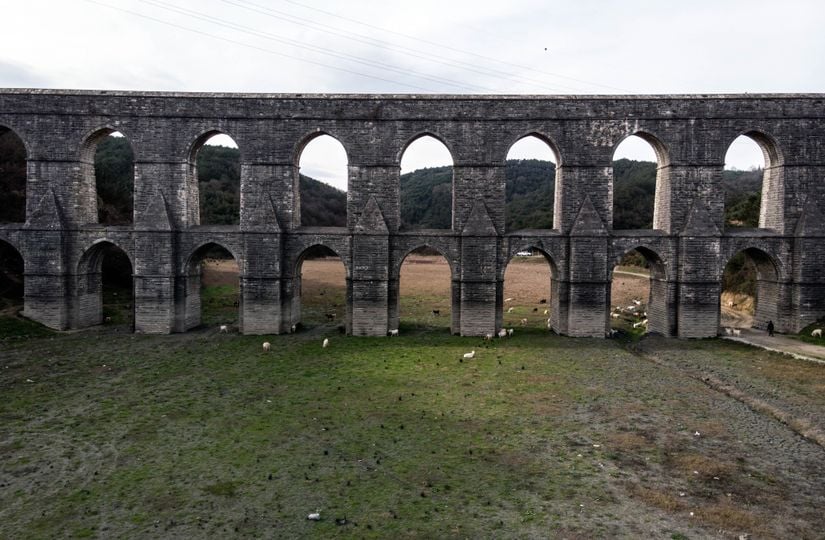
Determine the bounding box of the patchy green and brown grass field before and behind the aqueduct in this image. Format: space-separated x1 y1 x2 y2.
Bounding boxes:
0 259 825 540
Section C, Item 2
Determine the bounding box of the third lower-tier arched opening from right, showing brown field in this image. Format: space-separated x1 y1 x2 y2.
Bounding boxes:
499 250 559 331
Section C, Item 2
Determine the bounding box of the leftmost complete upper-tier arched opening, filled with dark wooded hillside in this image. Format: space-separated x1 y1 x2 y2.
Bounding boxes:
79 125 135 225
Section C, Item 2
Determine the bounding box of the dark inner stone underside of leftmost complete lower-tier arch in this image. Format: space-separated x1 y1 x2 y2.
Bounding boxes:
74 238 135 327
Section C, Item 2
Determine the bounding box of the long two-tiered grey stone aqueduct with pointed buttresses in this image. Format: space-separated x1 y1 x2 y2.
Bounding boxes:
0 89 825 338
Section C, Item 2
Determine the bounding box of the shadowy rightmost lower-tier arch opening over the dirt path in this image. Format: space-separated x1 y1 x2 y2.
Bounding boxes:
716 247 784 331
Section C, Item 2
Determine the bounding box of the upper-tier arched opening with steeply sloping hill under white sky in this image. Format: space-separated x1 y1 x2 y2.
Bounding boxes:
297 133 349 227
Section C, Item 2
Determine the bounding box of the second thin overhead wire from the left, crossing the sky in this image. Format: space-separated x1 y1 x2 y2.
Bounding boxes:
140 0 496 92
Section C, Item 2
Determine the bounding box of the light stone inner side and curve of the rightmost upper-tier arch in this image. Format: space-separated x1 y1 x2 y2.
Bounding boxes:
723 128 786 233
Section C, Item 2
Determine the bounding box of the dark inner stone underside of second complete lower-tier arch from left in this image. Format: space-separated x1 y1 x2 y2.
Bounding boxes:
179 243 243 330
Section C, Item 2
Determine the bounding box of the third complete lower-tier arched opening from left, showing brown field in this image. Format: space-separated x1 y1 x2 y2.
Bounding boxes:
292 244 349 330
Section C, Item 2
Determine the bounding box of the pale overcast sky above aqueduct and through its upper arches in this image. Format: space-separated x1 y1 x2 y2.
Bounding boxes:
0 0 825 191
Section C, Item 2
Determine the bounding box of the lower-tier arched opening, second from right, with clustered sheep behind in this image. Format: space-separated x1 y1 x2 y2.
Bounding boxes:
608 247 675 336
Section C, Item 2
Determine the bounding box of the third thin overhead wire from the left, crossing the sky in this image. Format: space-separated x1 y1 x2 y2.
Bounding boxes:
221 0 581 92
